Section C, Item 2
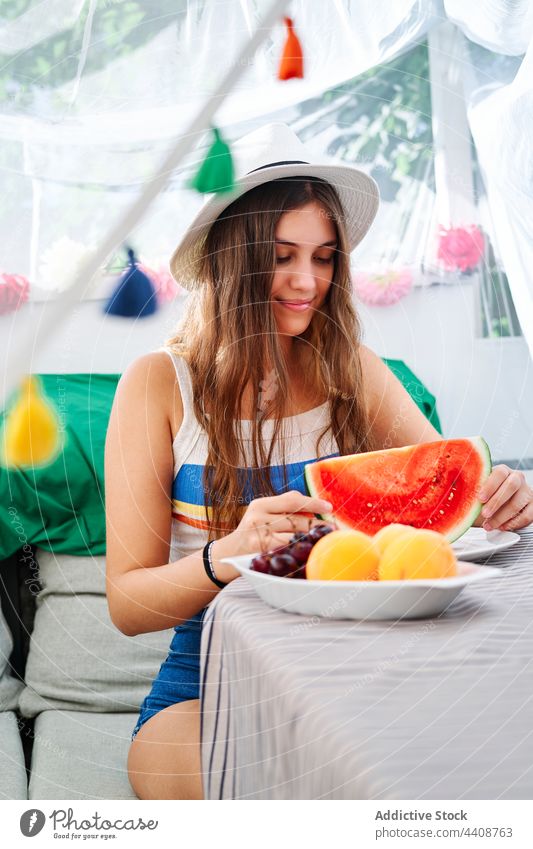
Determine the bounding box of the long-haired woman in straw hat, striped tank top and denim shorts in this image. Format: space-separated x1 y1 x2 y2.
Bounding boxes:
106 124 533 799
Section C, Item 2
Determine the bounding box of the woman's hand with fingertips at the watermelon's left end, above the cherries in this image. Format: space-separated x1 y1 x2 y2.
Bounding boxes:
211 490 331 581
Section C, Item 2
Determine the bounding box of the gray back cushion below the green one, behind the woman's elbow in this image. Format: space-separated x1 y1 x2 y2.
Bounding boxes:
19 550 174 717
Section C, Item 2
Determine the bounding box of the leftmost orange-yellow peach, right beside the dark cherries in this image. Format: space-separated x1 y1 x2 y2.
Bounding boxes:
305 530 379 581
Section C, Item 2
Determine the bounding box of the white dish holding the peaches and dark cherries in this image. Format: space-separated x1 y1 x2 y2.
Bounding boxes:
222 554 501 619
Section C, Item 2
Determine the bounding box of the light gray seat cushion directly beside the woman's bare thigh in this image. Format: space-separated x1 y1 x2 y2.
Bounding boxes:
28 710 137 799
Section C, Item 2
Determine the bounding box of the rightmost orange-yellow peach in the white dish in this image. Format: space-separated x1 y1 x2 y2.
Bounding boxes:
379 530 457 581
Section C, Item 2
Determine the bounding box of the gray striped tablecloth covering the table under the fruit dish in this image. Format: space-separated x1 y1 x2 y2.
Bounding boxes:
201 526 533 799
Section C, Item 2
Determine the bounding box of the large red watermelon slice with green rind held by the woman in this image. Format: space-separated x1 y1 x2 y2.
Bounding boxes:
305 436 492 542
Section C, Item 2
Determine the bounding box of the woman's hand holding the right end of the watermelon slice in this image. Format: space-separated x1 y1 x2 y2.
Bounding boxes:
478 464 533 531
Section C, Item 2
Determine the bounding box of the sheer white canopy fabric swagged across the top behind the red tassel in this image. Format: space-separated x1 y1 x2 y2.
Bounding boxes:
0 0 443 144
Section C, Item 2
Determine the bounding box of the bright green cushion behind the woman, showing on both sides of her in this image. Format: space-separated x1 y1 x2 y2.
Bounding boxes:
0 359 440 558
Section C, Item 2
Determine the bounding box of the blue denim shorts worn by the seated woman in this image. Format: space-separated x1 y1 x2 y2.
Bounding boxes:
131 607 207 740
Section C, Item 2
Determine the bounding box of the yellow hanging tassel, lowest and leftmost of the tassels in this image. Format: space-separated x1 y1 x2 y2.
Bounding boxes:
3 376 60 466
